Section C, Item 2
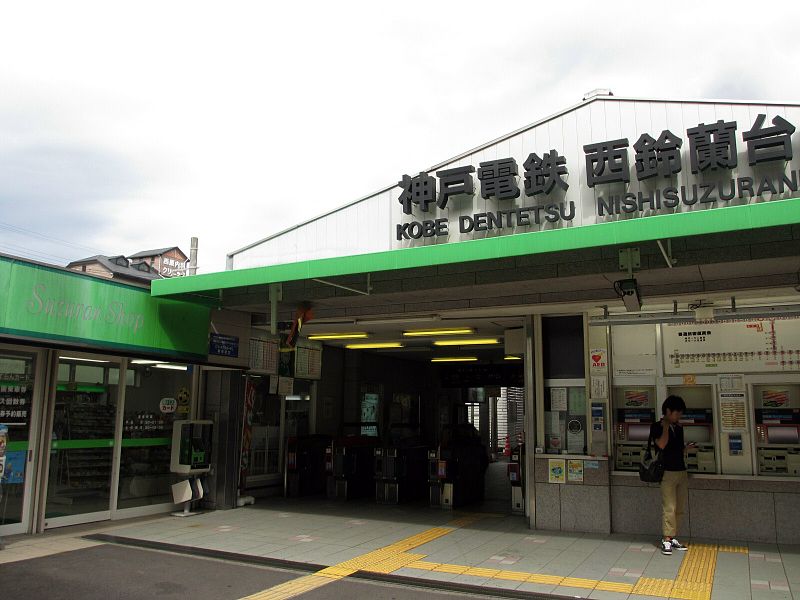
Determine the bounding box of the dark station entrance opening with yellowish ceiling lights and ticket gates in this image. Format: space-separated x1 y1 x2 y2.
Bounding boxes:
240 317 525 513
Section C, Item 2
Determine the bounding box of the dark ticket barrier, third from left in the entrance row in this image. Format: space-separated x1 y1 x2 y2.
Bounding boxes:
375 442 428 504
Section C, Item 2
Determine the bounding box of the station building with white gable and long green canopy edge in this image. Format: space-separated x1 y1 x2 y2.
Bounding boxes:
0 93 800 543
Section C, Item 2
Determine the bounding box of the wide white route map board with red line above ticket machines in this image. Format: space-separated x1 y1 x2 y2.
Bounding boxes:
662 318 800 375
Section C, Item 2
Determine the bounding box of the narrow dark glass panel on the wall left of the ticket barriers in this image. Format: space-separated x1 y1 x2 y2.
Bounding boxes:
247 377 281 480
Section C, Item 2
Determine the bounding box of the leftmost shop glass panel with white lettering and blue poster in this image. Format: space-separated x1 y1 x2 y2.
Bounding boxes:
0 351 34 525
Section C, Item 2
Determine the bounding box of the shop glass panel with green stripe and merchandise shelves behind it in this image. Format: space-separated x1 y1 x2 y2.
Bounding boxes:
45 360 117 519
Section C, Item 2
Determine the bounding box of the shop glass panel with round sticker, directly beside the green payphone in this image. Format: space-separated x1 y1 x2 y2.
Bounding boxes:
117 364 192 509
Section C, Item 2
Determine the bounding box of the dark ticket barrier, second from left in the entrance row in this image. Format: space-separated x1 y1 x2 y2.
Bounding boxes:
328 435 378 500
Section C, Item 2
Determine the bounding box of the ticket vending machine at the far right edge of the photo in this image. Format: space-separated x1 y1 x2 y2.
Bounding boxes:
753 384 800 476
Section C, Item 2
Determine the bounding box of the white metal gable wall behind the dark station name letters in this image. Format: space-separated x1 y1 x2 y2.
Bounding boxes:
233 98 800 269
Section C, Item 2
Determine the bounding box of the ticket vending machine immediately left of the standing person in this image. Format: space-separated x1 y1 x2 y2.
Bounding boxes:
613 385 661 471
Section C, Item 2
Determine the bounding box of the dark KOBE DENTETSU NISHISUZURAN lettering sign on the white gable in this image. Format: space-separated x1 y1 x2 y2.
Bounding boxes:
394 113 800 243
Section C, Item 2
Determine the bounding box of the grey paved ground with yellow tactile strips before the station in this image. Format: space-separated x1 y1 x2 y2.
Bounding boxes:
0 499 800 600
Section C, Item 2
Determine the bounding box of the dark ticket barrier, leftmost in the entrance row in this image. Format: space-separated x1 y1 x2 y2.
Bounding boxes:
284 435 331 498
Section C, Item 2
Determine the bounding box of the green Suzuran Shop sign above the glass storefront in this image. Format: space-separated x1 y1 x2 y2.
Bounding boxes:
0 257 209 359
